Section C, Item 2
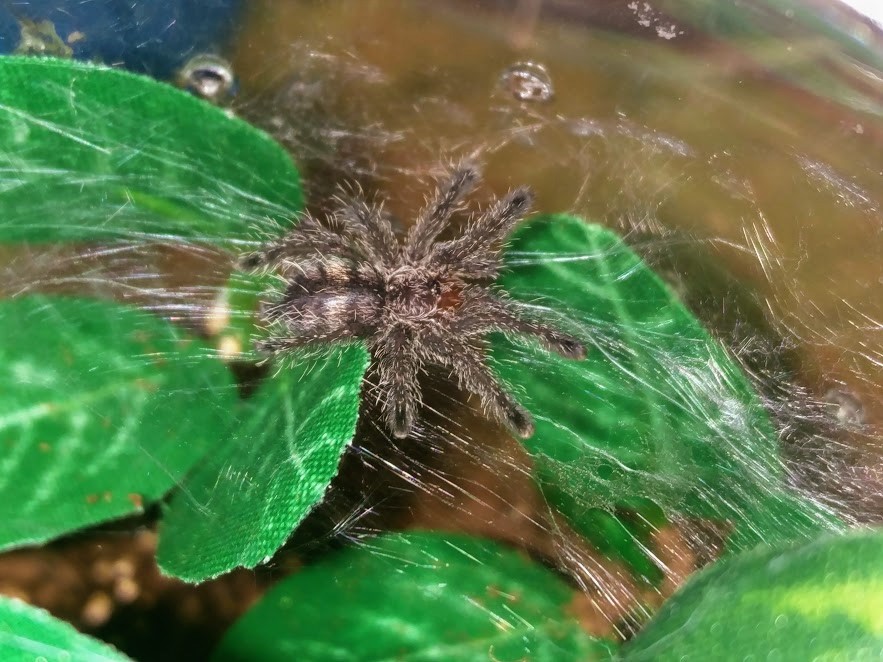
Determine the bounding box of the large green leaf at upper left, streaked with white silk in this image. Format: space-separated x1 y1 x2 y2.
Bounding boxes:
0 56 303 244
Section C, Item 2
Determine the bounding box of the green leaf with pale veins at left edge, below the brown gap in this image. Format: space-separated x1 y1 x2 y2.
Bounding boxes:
0 297 236 548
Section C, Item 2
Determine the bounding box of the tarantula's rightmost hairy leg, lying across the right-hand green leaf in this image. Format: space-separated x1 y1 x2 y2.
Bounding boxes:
453 291 586 359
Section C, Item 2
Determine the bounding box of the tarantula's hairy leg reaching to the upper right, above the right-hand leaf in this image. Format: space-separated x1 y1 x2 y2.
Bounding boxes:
431 186 534 278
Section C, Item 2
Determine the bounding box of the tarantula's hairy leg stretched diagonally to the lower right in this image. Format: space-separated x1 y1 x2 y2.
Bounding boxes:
427 336 534 439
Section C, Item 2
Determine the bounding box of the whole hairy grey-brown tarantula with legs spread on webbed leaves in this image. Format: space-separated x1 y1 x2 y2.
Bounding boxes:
243 165 586 438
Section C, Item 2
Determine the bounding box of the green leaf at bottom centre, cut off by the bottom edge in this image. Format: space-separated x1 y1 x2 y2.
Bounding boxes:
214 533 613 662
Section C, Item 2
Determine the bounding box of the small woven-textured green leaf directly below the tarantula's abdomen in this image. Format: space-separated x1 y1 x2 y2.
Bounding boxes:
157 344 368 582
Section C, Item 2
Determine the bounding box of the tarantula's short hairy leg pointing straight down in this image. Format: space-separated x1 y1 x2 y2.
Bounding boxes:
374 327 422 439
